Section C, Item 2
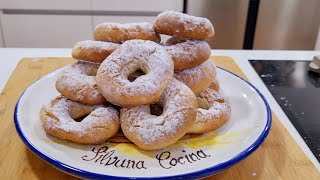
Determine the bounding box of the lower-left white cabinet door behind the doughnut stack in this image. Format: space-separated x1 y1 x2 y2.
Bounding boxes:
1 14 92 48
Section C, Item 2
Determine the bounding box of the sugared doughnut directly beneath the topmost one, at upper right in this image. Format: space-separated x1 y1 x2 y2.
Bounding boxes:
164 40 211 71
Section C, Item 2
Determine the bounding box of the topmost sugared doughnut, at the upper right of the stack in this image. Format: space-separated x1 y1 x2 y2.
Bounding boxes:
154 11 214 40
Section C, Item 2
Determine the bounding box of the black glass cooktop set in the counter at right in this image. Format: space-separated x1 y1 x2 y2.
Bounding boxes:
249 60 320 162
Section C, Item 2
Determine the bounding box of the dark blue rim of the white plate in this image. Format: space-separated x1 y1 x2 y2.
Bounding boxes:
14 67 272 179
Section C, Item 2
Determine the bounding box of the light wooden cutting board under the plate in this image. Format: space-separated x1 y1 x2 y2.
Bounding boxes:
0 56 320 179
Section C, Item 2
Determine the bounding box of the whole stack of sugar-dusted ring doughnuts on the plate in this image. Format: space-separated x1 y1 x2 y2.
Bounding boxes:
40 11 231 150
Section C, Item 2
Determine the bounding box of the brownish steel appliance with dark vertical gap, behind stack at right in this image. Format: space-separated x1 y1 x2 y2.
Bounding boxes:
185 0 320 50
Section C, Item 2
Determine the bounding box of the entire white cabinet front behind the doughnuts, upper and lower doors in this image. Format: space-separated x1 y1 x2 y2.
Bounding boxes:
0 0 183 48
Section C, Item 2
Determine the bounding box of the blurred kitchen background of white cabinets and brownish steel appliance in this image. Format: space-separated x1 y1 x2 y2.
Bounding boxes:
0 0 320 50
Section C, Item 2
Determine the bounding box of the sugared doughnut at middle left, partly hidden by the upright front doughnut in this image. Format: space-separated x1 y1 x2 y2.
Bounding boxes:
56 61 106 105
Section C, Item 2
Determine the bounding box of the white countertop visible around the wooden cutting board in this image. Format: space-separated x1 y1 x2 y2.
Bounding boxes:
0 48 320 171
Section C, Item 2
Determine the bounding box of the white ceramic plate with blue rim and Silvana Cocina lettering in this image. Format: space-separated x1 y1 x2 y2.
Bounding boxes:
14 68 271 179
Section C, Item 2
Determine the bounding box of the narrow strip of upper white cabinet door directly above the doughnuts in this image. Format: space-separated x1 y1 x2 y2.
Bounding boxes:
92 0 183 12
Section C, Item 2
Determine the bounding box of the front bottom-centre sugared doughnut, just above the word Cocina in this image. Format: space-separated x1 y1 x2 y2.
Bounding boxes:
120 79 197 150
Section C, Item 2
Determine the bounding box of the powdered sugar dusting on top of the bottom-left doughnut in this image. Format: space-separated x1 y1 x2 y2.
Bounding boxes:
42 97 119 138
